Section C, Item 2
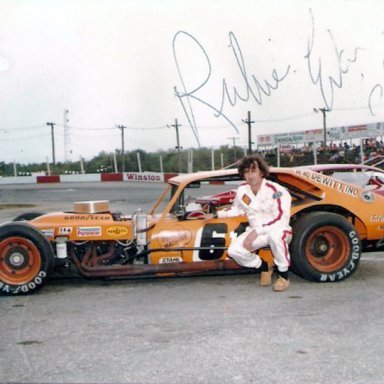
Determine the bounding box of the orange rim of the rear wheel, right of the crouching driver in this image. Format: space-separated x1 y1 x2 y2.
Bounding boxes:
305 226 351 273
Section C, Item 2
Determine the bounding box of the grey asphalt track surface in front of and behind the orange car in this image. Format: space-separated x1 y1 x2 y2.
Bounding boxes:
0 182 384 384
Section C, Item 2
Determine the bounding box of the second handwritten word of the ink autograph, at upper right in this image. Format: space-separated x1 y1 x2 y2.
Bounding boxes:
304 9 364 110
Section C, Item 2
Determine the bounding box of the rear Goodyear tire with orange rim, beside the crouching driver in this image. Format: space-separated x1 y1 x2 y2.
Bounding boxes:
290 212 362 282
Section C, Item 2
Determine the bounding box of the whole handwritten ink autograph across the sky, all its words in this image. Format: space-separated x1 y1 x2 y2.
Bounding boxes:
173 9 384 146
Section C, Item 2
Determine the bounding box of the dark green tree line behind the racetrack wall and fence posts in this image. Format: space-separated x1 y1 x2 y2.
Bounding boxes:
0 145 366 176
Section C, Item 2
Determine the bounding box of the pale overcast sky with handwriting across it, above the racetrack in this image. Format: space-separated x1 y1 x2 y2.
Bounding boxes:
0 0 384 163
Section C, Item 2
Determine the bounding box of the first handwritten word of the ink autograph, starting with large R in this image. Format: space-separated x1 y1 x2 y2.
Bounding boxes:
173 31 291 146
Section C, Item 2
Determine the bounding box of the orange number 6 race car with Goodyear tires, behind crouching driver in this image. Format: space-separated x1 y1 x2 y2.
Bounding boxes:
0 168 384 295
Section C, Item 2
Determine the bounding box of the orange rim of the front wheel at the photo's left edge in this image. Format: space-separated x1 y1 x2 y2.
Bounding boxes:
0 236 41 285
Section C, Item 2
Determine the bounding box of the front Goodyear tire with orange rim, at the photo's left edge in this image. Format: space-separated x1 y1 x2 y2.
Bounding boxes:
0 223 54 295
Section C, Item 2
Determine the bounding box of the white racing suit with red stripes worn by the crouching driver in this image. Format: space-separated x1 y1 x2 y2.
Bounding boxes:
218 179 292 272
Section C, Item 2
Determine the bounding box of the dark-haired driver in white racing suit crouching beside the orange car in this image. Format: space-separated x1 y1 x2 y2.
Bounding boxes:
217 155 292 292
